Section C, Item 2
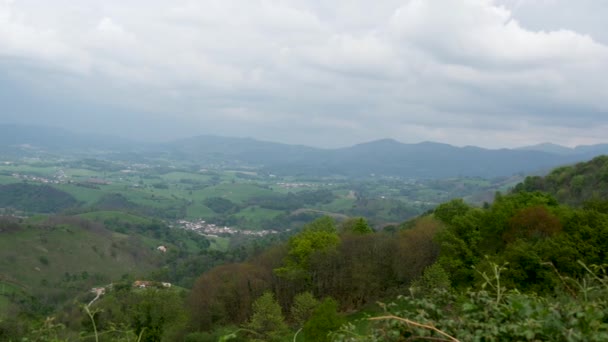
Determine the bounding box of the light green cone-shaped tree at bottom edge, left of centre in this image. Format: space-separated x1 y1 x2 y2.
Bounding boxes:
245 292 288 341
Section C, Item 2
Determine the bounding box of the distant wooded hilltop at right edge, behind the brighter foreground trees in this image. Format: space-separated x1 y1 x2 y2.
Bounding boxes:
515 156 608 205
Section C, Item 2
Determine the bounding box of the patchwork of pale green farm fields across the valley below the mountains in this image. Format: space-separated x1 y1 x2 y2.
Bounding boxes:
0 157 520 230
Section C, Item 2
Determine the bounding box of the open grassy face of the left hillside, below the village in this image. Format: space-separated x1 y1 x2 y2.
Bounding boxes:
0 220 171 316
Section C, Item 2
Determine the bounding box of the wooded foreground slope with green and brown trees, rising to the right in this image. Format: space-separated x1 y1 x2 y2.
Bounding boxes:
0 157 608 341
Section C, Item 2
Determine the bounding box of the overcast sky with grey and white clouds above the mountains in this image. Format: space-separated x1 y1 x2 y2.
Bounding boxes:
0 0 608 148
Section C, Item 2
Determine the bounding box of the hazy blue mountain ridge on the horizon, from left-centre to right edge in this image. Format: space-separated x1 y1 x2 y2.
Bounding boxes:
162 136 603 178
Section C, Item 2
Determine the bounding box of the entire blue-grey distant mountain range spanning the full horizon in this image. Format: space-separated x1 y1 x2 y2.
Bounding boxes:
0 125 608 178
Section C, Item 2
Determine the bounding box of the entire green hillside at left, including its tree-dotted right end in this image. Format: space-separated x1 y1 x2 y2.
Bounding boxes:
0 211 209 320
